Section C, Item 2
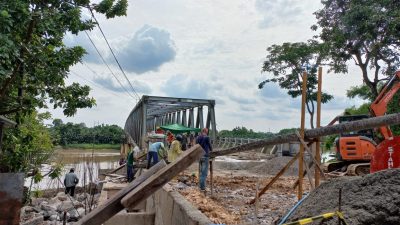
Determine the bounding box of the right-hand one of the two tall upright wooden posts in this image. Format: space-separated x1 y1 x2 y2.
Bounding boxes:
314 67 322 187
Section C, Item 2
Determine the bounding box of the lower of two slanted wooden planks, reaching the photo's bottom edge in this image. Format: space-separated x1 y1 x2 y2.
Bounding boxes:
77 160 167 225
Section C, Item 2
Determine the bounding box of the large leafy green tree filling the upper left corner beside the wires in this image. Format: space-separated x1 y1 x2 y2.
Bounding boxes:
0 0 127 121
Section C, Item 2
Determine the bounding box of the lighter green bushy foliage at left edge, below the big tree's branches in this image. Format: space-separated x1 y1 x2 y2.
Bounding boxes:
0 112 53 173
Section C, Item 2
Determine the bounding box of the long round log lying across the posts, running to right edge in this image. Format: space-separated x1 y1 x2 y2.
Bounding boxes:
210 113 400 158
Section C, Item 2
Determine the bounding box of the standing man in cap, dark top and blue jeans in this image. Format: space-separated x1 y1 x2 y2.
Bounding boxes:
196 128 212 191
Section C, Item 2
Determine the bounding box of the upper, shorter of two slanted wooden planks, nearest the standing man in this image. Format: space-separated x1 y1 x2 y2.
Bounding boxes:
121 144 204 208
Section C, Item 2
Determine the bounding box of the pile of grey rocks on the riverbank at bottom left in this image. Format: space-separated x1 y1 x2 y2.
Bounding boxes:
20 192 98 225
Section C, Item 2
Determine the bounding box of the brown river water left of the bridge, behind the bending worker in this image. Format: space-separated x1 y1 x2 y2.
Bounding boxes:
25 149 120 190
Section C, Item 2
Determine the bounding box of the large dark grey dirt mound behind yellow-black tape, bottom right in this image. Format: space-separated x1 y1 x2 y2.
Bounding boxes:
289 169 400 225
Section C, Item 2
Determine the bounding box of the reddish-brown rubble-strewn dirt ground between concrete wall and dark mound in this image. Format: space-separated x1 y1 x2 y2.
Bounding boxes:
171 153 309 225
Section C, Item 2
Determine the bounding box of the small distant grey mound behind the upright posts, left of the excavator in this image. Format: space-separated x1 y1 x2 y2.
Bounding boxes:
249 156 298 176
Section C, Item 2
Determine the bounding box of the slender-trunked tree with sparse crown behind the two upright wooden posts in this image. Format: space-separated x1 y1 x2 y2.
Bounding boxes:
259 40 333 128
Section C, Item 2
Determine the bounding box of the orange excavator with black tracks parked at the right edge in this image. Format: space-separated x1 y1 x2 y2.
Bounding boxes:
324 71 400 175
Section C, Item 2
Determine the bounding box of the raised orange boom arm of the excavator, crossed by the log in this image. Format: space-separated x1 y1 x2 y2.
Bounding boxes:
370 71 400 140
